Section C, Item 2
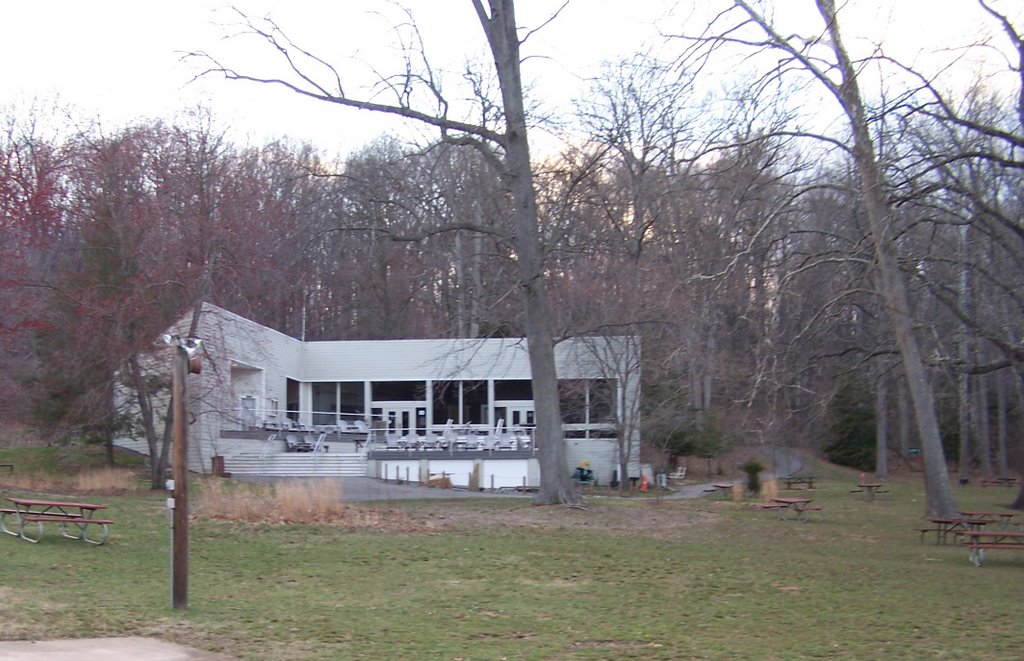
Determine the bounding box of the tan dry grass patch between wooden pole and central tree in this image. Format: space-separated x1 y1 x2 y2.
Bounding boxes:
196 478 431 532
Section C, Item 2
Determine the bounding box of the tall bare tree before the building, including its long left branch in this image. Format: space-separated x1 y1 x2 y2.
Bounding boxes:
195 0 579 503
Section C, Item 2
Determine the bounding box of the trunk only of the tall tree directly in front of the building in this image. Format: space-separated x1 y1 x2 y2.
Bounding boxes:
473 0 579 503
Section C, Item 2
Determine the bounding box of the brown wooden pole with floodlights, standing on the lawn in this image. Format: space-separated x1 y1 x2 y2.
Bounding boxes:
171 346 188 610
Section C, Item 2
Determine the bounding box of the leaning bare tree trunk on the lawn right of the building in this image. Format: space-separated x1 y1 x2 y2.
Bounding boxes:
816 0 959 517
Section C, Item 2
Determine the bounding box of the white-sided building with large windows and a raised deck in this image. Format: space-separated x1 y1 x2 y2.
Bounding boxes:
119 304 640 490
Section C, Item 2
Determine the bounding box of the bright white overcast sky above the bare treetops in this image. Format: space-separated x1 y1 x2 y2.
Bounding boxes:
0 0 1024 153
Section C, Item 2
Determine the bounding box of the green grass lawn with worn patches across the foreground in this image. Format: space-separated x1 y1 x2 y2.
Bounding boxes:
0 454 1024 659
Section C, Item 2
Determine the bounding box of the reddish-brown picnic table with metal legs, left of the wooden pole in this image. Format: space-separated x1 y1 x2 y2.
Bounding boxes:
0 496 114 545
